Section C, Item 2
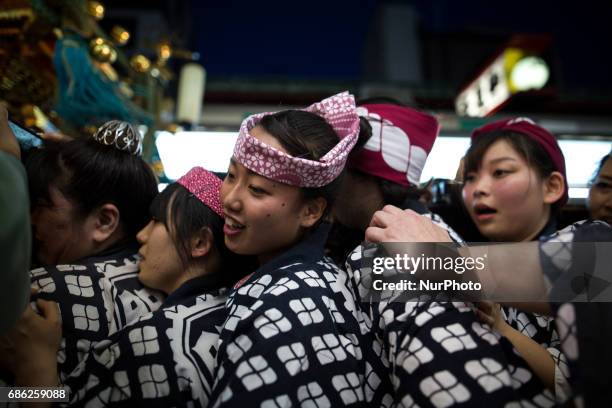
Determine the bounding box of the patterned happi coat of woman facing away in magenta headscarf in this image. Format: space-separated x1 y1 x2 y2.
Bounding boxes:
346 214 542 407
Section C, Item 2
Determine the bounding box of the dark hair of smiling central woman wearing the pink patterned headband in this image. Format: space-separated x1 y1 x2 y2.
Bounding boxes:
259 110 344 221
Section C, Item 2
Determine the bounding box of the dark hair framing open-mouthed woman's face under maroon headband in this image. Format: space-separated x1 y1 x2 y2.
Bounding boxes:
463 130 560 215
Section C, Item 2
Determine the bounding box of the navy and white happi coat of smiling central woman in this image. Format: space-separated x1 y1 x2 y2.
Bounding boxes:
213 225 392 407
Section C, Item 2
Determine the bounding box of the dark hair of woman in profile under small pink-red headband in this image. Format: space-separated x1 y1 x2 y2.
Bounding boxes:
150 183 255 284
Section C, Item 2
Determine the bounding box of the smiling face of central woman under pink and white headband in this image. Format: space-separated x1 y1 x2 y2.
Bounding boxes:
221 127 310 263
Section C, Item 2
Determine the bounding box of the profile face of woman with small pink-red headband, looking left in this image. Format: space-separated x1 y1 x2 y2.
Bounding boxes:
136 220 184 294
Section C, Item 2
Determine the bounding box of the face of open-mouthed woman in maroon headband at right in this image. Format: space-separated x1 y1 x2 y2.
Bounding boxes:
463 140 550 242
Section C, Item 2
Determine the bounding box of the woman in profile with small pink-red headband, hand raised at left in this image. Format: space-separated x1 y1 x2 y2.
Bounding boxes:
0 167 248 407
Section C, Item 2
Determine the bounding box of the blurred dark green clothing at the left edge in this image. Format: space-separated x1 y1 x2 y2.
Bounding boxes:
0 151 32 335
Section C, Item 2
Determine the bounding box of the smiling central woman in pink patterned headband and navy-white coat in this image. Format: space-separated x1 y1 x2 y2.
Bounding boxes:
214 93 392 406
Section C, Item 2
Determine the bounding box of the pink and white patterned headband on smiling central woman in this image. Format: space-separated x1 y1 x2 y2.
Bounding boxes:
234 92 359 187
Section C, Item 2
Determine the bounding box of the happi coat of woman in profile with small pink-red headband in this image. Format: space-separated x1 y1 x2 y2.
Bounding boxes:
64 275 227 407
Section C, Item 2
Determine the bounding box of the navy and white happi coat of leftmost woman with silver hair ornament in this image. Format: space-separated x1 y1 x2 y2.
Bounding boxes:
30 245 162 380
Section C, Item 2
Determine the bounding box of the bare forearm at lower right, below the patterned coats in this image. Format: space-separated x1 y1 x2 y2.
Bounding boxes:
499 325 555 392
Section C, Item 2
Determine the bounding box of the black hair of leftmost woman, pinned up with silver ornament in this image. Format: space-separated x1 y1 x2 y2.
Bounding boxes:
26 139 157 240
